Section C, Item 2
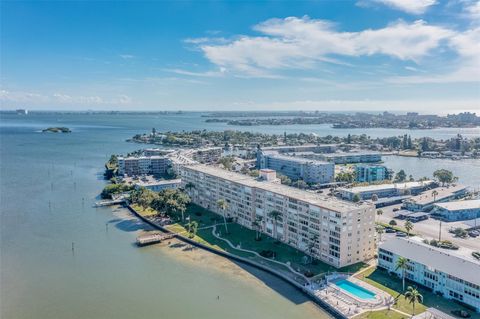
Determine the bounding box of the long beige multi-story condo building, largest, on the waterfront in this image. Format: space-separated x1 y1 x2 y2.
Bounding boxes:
180 164 375 267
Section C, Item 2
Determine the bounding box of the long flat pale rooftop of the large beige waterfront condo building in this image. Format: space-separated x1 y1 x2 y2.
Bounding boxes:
186 164 373 212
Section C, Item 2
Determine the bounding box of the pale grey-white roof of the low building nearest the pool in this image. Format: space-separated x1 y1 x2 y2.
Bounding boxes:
379 237 480 285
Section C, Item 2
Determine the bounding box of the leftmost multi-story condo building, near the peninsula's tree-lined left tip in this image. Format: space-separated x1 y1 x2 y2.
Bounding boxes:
118 156 169 176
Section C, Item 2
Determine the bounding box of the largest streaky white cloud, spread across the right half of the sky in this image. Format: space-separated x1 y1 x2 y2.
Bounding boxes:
196 16 454 76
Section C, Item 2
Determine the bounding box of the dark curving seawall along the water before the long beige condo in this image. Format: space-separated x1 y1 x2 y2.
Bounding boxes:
125 205 347 319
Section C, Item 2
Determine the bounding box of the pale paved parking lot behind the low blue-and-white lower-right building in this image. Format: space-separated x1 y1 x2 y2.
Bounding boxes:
377 204 480 251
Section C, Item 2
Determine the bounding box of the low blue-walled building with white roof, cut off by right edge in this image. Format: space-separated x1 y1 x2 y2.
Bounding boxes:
432 199 480 222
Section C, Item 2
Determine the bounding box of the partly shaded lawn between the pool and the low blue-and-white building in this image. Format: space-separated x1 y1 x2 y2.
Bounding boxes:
357 268 474 318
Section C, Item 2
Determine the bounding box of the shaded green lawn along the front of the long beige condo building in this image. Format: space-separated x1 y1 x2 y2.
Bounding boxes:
162 205 366 275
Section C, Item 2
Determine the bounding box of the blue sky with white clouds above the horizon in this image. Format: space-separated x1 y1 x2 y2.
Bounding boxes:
0 0 480 113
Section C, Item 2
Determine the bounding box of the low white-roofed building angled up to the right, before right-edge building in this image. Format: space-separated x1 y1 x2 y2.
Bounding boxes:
402 185 467 212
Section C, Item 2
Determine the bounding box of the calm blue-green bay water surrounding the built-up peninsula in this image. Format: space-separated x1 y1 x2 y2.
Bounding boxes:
0 114 480 319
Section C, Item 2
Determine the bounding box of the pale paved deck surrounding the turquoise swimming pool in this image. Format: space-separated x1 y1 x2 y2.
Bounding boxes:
314 273 394 318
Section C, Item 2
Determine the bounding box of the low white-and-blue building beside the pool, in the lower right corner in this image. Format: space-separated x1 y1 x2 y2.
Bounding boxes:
378 237 480 312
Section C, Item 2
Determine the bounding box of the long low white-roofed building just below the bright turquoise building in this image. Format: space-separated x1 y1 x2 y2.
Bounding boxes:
338 181 433 200
